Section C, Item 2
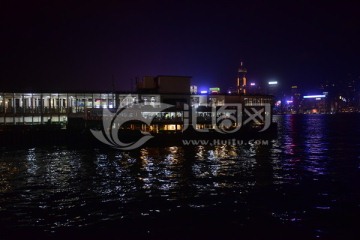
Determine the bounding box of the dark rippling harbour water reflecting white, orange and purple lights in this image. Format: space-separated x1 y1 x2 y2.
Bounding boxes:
0 115 360 237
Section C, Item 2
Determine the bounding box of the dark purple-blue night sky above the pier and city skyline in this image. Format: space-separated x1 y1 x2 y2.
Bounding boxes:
0 0 360 91
